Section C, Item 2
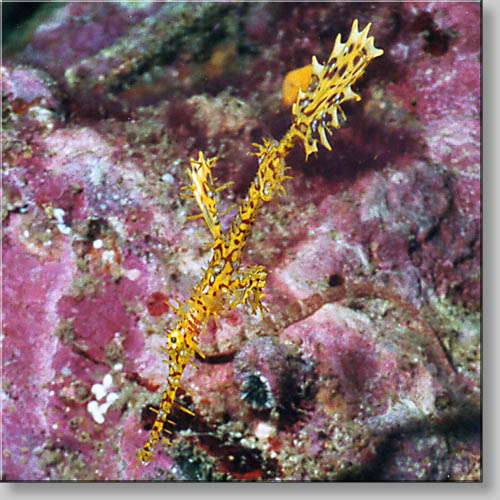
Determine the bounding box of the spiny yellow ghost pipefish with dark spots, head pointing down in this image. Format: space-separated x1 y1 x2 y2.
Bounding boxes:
137 19 383 463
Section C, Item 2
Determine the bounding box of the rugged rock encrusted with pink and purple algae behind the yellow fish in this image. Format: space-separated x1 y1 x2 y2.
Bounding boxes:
1 2 482 481
